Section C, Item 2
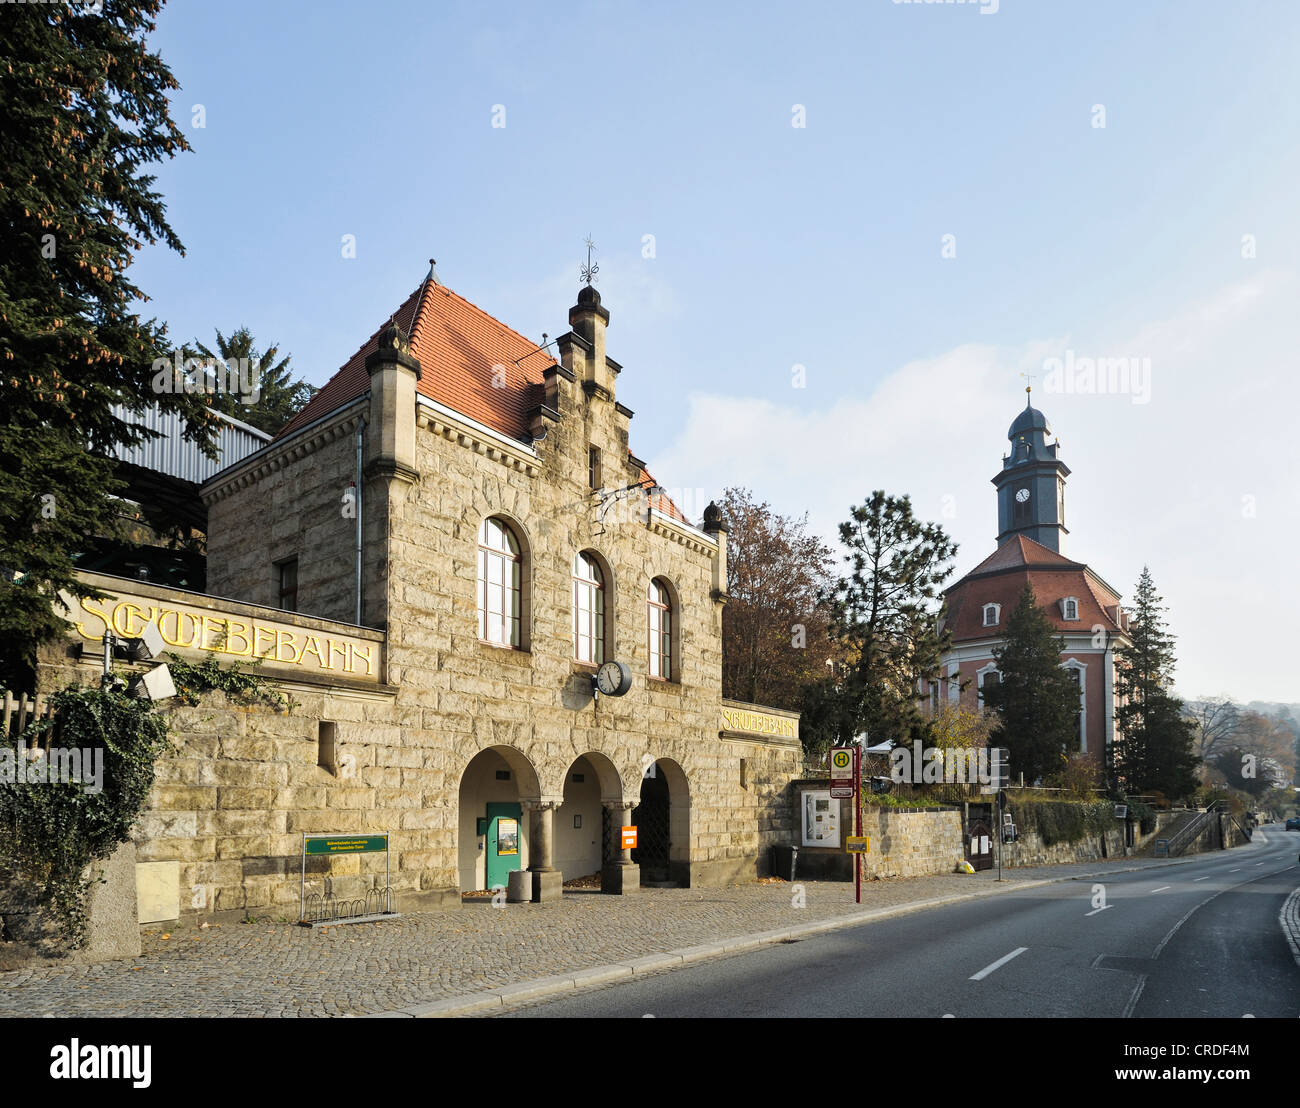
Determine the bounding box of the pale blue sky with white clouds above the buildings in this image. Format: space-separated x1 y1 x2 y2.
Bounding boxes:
133 0 1300 701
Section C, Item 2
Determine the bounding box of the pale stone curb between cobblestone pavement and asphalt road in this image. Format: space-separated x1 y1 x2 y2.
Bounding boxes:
369 854 1237 1020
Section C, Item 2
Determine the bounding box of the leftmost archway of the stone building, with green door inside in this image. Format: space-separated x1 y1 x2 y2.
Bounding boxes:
456 746 540 892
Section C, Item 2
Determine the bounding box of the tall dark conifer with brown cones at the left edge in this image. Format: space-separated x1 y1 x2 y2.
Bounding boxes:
0 0 215 688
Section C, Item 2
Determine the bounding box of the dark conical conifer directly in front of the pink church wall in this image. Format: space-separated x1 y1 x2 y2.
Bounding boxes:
984 585 1079 782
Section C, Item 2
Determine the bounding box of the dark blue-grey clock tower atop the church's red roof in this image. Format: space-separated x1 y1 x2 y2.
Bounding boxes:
993 389 1070 554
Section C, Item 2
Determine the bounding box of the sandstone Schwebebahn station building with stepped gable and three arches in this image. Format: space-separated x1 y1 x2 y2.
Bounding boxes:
40 269 801 918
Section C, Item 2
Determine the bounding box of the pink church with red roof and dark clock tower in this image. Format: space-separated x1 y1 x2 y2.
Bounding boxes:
930 403 1130 771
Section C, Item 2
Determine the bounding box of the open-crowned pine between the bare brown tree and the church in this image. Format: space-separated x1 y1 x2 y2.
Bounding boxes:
831 489 957 743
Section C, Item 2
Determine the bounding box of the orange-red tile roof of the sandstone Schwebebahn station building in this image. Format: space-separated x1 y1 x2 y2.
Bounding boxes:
276 280 686 523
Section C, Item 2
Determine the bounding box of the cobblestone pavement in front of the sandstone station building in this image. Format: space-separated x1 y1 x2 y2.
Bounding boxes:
0 858 1196 1017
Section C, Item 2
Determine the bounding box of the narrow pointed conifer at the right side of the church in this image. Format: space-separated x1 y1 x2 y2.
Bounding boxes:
1112 566 1200 797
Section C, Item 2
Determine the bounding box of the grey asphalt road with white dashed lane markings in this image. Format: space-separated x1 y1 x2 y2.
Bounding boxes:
498 826 1300 1018
